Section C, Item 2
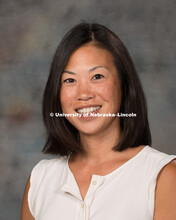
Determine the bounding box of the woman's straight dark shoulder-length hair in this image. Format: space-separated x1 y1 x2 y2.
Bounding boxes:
43 23 151 156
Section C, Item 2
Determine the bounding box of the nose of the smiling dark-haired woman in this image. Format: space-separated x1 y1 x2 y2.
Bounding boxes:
77 82 95 101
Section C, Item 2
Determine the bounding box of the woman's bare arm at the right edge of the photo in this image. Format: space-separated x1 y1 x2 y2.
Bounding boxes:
154 160 176 220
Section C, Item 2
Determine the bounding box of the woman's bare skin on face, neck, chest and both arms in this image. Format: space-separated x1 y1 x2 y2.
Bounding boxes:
21 43 176 220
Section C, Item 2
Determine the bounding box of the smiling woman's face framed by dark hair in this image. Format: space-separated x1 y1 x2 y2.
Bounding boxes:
60 44 121 135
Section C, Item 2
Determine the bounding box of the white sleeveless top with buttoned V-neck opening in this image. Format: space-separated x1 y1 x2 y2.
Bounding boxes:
28 146 176 220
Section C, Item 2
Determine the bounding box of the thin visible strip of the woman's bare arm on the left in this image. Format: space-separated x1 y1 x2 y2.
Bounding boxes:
21 177 35 220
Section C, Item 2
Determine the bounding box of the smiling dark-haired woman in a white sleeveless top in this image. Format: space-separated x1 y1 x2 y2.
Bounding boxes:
22 23 176 220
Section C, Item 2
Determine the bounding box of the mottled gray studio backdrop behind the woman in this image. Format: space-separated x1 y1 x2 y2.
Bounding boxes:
0 0 176 220
